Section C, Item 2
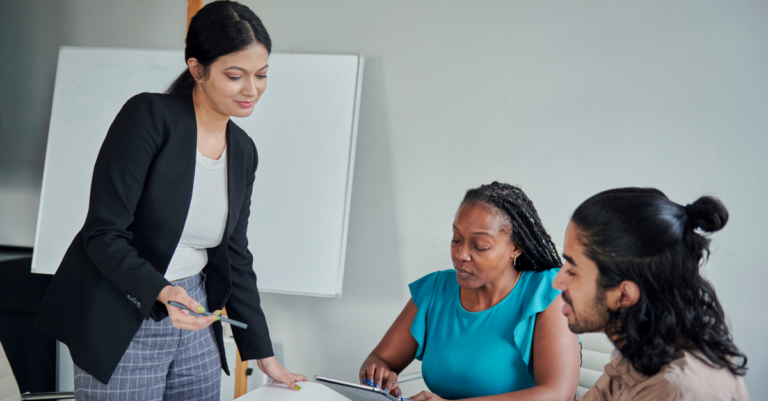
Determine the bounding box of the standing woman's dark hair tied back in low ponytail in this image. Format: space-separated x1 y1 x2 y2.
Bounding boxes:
165 0 272 96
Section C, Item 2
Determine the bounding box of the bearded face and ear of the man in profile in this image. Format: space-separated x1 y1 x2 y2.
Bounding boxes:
552 222 640 340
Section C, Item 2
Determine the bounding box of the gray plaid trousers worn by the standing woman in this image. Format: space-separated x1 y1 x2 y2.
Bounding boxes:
74 273 221 401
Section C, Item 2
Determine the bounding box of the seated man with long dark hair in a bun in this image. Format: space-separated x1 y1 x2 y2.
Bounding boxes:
553 188 749 401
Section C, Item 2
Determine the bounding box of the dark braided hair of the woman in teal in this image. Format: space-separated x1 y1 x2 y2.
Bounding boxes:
459 181 563 270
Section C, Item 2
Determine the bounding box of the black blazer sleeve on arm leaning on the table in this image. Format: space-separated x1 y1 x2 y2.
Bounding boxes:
227 138 274 361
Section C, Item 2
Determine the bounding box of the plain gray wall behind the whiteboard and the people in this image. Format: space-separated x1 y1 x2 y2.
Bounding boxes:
0 0 768 399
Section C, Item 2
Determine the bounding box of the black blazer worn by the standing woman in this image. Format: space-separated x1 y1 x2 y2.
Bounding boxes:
35 93 274 383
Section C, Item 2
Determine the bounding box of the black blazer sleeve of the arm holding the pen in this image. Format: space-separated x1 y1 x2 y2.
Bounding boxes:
82 94 170 319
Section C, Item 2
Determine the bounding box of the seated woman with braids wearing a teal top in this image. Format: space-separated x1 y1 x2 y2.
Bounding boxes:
360 182 579 401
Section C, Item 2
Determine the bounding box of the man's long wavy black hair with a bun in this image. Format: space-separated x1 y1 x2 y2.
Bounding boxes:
571 188 747 376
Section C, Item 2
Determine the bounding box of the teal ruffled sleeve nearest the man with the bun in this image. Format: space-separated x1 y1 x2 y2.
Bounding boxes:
512 269 561 377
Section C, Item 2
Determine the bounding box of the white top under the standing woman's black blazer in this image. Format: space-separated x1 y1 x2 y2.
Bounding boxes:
165 147 229 281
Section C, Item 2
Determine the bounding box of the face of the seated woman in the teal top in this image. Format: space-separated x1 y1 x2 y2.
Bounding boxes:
451 202 521 312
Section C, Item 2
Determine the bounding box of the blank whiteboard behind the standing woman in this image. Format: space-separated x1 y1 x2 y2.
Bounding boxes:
32 47 363 297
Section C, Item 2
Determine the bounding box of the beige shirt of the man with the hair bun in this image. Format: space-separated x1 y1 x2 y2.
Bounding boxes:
579 351 749 401
